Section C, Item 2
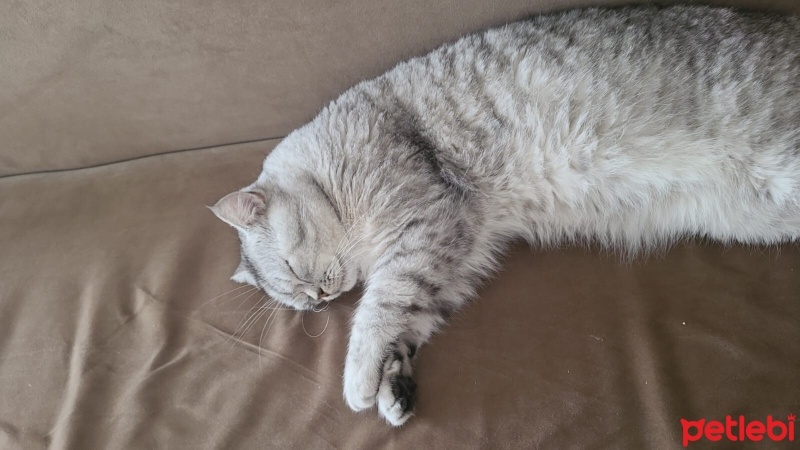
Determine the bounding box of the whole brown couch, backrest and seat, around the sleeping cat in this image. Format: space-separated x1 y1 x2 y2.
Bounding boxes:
0 0 800 449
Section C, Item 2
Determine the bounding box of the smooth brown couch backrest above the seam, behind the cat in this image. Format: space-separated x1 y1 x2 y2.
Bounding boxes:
0 0 800 176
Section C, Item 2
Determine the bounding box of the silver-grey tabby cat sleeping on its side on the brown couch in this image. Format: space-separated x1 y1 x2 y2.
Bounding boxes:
212 7 800 425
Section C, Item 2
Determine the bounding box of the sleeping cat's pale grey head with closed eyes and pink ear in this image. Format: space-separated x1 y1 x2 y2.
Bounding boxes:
210 182 359 310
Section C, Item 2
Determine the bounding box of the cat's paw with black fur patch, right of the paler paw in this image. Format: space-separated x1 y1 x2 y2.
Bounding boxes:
377 359 417 427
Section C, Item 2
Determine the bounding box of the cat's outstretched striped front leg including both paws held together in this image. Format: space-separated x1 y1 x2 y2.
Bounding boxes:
344 208 484 425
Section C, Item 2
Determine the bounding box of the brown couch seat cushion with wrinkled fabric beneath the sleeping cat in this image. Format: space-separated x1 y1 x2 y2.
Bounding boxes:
0 143 800 449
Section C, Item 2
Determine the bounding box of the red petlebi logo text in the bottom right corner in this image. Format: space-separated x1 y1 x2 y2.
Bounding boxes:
681 414 797 447
